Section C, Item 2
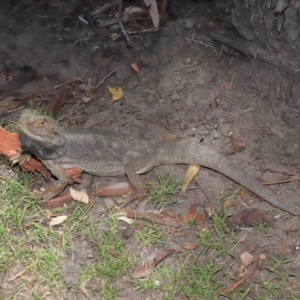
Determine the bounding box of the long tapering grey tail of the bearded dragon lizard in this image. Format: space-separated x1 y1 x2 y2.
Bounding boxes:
158 142 300 215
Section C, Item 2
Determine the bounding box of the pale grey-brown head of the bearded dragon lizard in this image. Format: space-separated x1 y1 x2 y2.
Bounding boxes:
18 109 64 148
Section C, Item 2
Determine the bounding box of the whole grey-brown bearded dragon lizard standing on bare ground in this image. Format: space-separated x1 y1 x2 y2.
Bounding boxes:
19 109 300 215
